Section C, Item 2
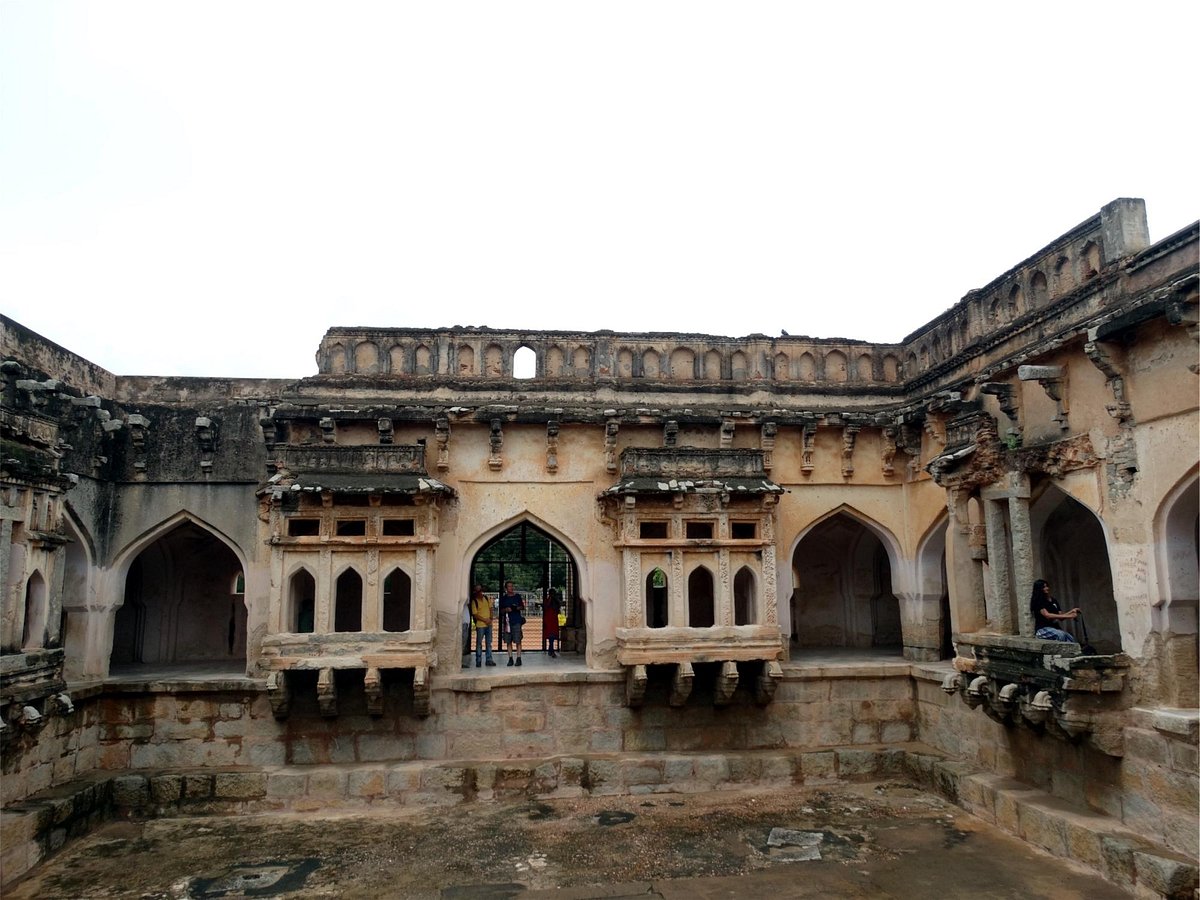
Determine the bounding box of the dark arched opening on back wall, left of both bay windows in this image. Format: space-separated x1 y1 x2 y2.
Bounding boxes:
110 521 246 672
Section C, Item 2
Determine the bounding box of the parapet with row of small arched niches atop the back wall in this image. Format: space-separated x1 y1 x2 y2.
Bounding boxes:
317 326 902 389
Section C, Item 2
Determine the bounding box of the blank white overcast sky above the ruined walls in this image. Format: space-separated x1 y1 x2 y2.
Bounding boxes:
0 0 1200 377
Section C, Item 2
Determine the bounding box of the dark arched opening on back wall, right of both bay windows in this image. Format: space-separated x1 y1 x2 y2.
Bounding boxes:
792 512 902 654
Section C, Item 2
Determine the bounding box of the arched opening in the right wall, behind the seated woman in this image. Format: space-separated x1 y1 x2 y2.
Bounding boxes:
1032 485 1121 653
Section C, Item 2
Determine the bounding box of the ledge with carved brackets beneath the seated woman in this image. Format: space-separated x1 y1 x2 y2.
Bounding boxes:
942 634 1132 756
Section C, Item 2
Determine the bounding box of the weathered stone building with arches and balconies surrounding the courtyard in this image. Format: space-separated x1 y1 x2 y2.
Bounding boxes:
0 199 1200 893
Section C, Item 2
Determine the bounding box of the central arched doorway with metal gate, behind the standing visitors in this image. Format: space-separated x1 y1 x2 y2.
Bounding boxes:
470 521 584 653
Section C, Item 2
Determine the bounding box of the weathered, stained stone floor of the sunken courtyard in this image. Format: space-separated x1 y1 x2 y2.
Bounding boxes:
5 782 1128 900
